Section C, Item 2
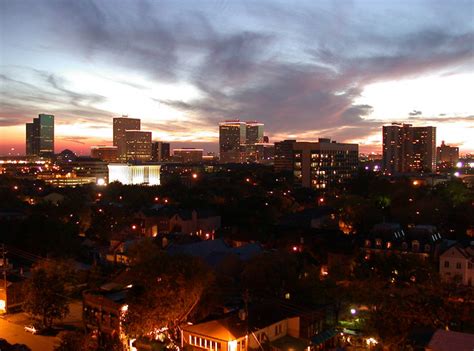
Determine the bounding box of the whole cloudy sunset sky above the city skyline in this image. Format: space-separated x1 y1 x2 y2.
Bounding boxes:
0 0 474 154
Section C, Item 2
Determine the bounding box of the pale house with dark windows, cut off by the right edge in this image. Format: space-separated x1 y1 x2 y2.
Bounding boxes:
439 242 474 286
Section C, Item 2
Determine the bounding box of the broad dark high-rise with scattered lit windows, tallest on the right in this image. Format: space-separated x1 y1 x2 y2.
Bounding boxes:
382 123 436 174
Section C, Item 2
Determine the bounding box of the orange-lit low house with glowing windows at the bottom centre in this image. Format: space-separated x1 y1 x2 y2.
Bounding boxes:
181 303 335 351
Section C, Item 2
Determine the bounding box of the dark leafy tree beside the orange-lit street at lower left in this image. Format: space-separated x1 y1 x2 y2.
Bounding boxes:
23 260 71 328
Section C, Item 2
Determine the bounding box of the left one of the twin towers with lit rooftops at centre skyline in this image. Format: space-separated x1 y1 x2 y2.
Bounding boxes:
219 120 246 163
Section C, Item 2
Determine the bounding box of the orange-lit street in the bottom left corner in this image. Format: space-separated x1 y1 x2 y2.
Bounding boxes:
0 300 82 351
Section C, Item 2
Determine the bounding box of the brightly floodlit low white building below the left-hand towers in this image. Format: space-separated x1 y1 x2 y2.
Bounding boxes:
108 163 161 185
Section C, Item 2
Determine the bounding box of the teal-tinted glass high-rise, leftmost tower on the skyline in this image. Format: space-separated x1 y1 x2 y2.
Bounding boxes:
26 113 54 157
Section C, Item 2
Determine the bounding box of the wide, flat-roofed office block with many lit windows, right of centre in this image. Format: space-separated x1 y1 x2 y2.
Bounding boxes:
288 138 359 189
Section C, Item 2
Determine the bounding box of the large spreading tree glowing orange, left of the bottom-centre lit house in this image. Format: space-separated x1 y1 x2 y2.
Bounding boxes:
123 254 213 339
